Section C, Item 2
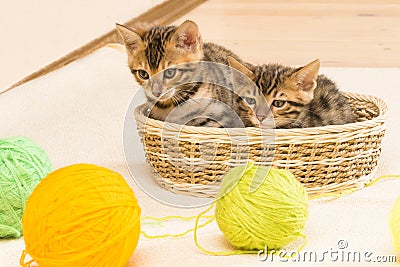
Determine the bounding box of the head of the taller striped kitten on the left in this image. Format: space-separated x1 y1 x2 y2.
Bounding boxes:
117 21 203 105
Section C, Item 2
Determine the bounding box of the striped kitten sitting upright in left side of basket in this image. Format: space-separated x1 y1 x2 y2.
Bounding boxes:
117 21 252 127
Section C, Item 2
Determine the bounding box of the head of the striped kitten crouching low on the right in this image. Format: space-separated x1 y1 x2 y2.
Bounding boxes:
231 57 319 128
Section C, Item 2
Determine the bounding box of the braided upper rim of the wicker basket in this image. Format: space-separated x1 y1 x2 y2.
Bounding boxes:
135 91 388 139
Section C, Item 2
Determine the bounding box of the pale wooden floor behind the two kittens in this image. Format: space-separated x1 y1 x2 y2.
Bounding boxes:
176 0 400 67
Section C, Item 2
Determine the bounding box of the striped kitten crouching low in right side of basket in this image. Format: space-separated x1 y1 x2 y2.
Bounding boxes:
229 58 357 128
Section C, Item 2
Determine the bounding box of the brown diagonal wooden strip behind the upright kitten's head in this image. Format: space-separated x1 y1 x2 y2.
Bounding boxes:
0 0 206 94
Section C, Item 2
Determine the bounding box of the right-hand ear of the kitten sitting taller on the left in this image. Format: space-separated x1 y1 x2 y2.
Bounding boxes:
171 20 203 53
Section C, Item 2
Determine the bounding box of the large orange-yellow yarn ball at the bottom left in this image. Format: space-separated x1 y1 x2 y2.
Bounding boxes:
21 164 141 267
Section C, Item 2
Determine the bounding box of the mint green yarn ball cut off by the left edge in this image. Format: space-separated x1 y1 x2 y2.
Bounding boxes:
0 137 51 238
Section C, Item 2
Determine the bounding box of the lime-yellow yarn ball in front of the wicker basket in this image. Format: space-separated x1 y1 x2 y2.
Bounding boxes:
215 162 308 250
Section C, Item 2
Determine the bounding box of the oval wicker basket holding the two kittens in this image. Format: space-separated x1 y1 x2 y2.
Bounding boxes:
135 92 387 197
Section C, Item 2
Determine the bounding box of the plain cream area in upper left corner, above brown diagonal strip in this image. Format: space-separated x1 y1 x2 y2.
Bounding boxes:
0 0 161 91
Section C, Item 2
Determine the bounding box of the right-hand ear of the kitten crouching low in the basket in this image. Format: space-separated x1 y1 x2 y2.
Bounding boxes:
293 59 320 93
